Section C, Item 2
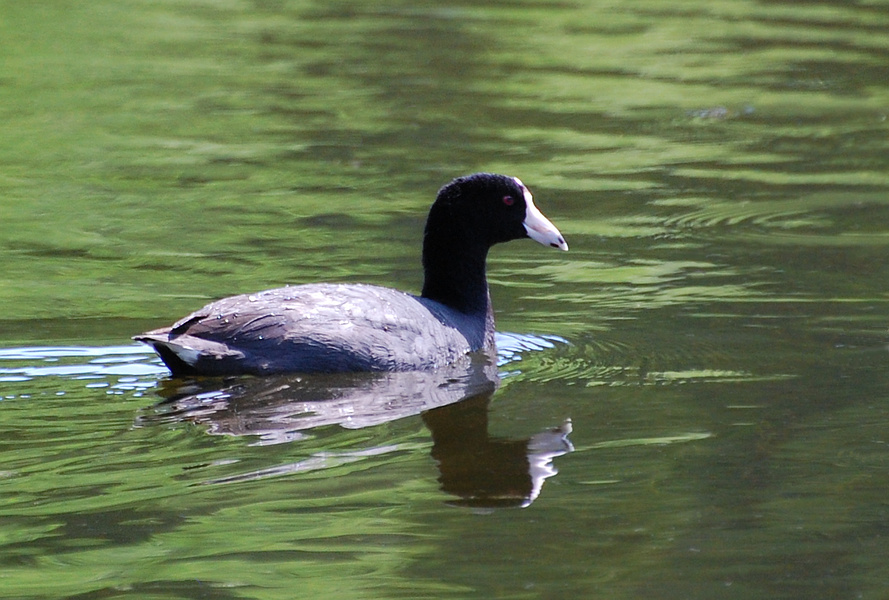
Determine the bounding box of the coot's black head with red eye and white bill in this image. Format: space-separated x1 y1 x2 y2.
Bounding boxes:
426 173 568 250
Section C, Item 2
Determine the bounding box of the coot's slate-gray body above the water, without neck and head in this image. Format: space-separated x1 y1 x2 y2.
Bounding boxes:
135 283 494 375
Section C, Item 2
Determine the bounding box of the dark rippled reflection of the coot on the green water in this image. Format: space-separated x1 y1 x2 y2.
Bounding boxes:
137 355 573 508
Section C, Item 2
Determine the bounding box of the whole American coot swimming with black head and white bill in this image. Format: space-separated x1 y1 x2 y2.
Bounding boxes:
133 173 568 376
